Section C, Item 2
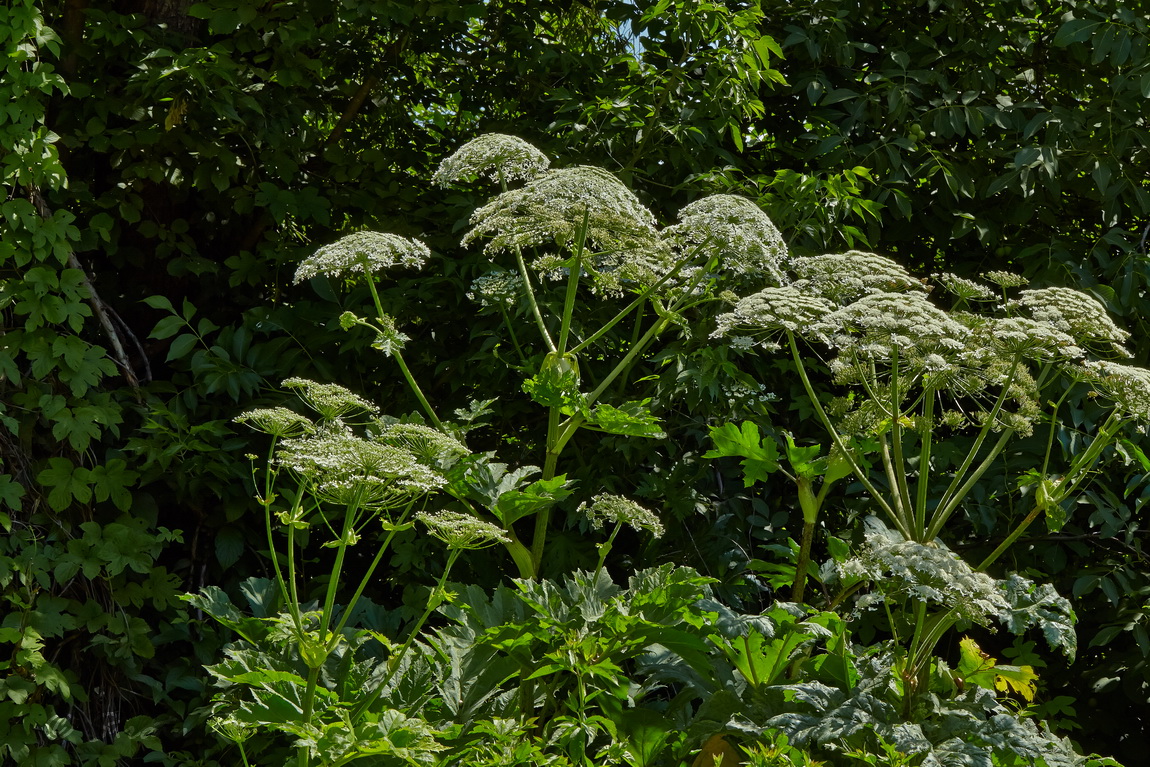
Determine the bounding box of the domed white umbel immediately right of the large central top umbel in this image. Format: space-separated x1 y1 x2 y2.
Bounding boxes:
664 194 789 284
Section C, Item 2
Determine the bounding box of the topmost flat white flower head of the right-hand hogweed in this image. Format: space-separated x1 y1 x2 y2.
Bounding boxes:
791 251 922 304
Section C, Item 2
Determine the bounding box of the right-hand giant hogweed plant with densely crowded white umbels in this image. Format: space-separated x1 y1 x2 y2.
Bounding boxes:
710 252 1150 764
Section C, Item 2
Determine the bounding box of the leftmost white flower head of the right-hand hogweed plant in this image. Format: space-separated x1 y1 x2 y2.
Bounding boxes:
711 287 835 347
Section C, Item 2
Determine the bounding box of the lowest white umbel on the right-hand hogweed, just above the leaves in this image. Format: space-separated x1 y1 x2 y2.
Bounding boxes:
840 516 1010 624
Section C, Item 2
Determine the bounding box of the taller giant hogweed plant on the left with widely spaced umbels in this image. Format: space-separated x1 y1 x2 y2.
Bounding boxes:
190 136 800 765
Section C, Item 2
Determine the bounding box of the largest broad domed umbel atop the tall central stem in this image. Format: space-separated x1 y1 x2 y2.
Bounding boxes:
463 166 664 269
